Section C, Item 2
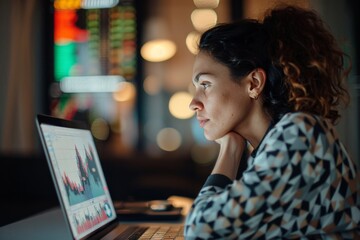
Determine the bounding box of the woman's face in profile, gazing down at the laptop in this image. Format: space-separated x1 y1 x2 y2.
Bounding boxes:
190 52 251 140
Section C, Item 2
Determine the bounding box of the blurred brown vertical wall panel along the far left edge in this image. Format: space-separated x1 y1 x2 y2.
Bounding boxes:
0 0 47 154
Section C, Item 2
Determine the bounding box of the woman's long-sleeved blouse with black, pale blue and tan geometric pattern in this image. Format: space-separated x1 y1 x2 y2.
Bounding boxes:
184 113 360 239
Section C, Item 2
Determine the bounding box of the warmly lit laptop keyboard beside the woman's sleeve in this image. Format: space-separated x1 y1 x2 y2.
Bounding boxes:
128 226 184 240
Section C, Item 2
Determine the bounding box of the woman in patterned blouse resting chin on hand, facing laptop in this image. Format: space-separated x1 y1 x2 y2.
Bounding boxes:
185 6 360 239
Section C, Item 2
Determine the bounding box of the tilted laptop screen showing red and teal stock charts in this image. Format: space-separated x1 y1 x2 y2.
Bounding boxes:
38 115 116 239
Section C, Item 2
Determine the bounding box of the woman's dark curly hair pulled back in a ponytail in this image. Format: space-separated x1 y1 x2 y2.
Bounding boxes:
199 6 350 123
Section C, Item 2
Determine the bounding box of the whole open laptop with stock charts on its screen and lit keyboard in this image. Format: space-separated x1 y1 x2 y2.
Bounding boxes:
36 114 183 239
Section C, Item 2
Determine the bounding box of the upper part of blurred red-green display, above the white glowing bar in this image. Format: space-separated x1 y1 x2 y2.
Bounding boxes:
54 1 136 91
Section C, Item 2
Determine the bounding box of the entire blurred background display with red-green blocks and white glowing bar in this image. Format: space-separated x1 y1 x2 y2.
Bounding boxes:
51 0 137 153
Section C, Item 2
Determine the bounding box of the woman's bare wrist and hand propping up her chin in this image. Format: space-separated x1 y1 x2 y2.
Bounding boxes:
212 132 245 179
